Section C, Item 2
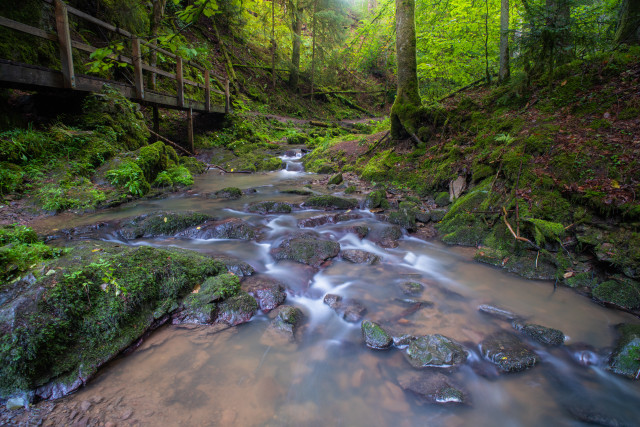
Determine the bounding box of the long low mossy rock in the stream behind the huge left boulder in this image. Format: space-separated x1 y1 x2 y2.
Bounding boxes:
119 212 213 240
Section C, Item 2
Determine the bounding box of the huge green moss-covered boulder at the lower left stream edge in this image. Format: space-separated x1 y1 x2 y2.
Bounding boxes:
0 241 224 399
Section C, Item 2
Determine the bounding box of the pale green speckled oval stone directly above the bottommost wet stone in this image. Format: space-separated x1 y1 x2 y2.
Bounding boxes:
405 334 467 368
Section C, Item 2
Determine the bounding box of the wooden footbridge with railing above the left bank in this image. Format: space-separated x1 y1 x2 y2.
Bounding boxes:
0 0 231 151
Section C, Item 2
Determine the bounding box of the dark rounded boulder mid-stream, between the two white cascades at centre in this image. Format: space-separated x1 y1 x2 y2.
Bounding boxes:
271 234 340 267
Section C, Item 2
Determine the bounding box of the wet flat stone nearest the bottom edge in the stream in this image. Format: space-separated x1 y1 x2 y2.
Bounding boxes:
398 371 468 405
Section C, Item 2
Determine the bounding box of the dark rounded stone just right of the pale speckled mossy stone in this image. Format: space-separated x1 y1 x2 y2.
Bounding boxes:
480 331 538 372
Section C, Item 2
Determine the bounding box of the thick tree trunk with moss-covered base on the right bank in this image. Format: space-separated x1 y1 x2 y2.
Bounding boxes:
391 0 421 140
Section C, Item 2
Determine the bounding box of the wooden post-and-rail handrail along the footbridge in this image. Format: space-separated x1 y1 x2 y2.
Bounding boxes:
0 0 231 112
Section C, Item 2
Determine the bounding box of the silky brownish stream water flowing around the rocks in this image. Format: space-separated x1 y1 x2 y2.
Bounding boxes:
40 152 640 426
